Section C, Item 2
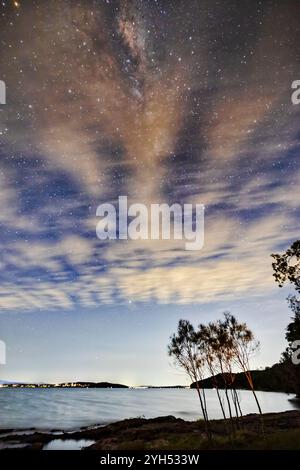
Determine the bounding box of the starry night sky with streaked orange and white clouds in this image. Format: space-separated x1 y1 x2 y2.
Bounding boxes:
0 0 300 385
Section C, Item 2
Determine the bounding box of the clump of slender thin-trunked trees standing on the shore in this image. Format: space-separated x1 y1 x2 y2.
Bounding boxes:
168 312 263 439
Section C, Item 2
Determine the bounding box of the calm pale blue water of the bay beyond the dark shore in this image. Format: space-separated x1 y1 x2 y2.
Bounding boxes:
0 389 296 430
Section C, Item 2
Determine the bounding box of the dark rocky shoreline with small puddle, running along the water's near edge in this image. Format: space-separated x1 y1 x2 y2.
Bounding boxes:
0 410 300 451
